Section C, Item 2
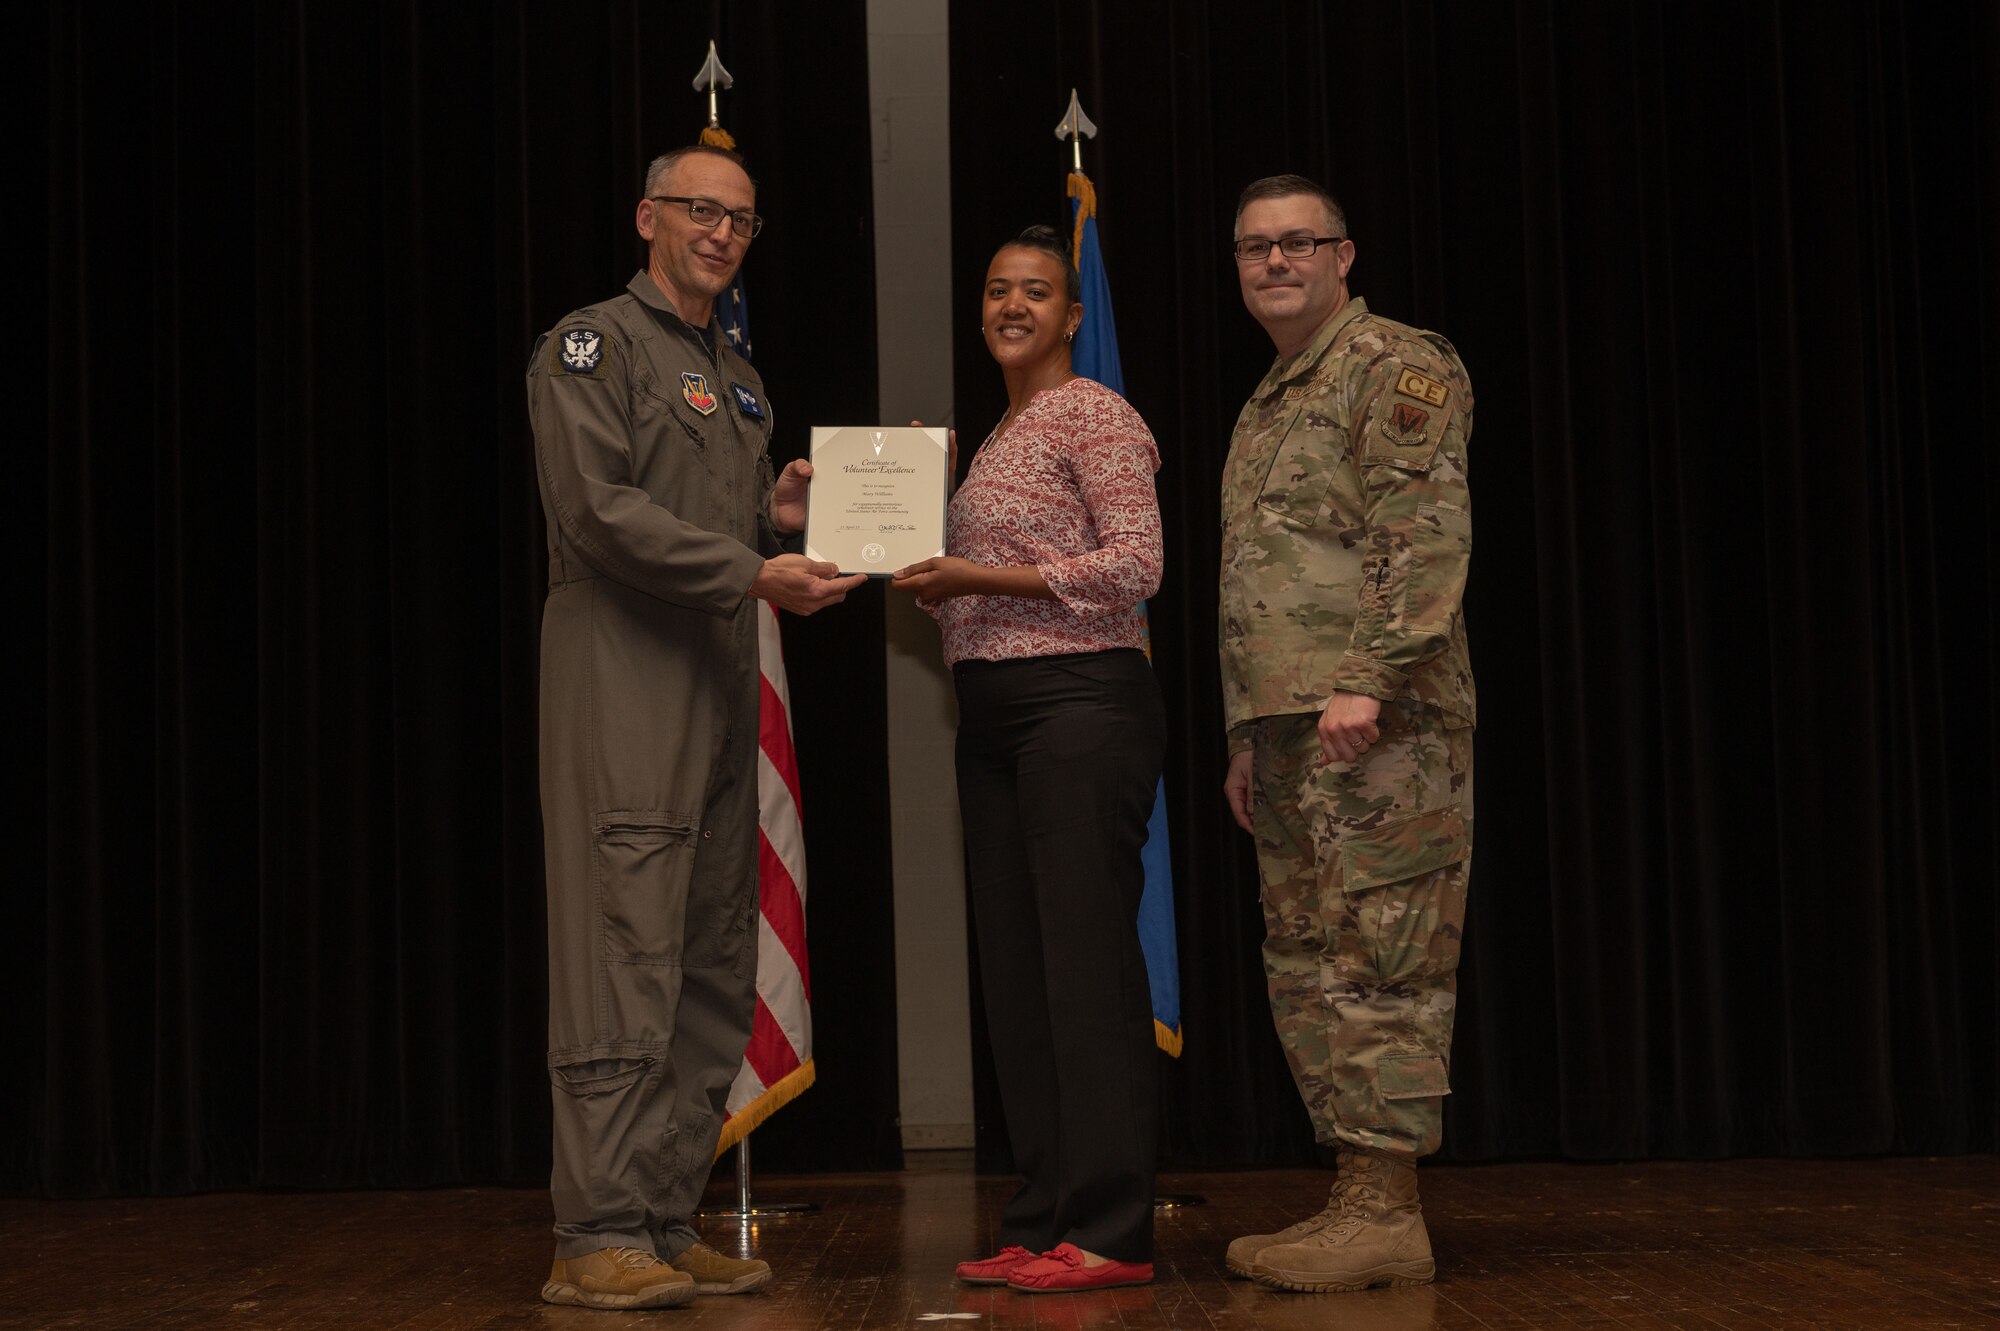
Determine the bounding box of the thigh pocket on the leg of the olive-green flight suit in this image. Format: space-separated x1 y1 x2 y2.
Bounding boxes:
592 809 694 1041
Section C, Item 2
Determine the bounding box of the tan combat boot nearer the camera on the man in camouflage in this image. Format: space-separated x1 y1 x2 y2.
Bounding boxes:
1250 1151 1438 1293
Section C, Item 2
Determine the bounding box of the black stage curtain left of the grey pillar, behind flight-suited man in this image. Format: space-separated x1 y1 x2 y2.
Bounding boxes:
23 0 900 1193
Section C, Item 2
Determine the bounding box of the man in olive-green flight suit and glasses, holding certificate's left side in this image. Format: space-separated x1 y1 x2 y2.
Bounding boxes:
528 148 864 1309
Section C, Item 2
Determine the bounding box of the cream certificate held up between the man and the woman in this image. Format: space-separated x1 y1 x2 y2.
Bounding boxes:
806 426 952 576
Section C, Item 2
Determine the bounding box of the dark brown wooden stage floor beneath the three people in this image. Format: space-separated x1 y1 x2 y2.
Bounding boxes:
0 1157 2000 1331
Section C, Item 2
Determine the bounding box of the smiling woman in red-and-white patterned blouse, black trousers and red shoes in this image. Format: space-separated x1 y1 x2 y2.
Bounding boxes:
896 226 1166 1293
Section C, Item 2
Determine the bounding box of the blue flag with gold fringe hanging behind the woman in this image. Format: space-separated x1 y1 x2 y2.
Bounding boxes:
1070 172 1180 1057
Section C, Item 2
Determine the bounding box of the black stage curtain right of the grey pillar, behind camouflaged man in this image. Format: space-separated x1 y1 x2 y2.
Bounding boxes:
952 0 2000 1165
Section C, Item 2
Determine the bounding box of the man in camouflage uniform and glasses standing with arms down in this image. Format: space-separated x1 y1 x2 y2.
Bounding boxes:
1220 176 1474 1289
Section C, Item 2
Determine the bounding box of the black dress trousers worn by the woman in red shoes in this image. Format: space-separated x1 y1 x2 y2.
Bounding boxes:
954 648 1166 1261
